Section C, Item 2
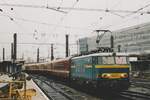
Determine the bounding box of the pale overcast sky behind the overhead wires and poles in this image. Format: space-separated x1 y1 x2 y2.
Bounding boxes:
0 0 150 61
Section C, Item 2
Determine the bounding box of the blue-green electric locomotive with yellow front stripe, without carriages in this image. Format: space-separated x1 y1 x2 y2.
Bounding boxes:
70 53 130 90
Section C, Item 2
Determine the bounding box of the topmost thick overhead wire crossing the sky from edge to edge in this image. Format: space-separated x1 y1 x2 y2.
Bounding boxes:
0 4 150 14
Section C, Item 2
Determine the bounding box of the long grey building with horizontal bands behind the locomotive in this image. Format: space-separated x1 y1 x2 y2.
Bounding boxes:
79 23 150 53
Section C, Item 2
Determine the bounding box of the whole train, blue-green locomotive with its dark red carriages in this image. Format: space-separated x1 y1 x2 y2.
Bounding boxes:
24 53 130 91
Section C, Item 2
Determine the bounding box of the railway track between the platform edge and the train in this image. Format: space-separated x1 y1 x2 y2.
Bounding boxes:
32 76 88 100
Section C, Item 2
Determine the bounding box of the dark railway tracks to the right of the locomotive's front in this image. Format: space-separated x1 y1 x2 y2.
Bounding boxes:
120 79 150 100
